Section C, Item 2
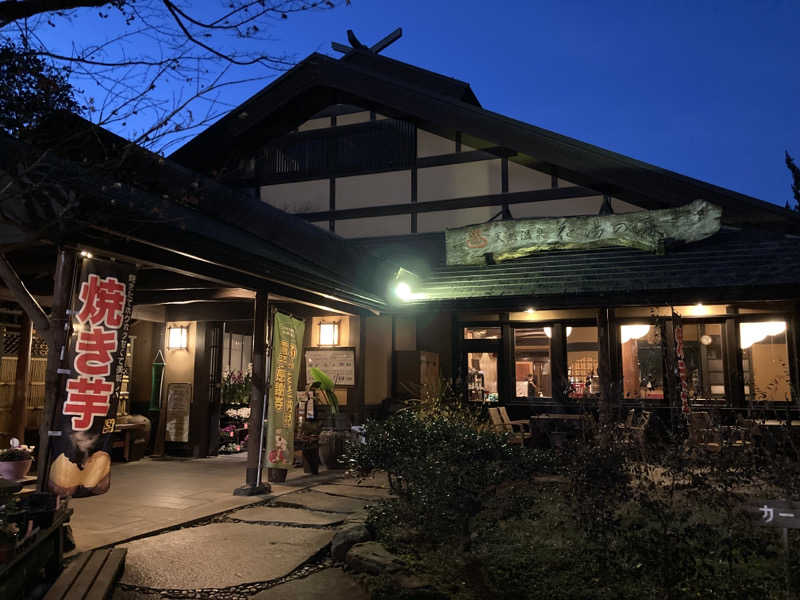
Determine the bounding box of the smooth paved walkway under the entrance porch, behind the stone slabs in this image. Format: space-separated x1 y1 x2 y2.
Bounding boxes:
70 453 352 552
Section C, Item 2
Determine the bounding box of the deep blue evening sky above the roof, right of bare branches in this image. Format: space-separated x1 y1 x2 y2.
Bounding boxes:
37 0 800 205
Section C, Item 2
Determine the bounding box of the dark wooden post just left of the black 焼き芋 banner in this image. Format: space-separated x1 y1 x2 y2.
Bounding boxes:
37 250 75 492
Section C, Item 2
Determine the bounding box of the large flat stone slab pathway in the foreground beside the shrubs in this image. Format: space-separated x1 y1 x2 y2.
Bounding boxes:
113 475 389 600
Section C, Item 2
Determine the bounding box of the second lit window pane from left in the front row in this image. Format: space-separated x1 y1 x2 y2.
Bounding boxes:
514 327 553 400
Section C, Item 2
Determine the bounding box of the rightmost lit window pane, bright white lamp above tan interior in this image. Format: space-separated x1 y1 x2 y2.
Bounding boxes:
739 321 791 402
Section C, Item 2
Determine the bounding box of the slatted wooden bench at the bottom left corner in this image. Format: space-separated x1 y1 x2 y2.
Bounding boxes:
44 548 127 600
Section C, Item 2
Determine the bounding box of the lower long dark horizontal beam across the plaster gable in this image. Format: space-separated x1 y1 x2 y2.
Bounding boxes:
296 186 597 221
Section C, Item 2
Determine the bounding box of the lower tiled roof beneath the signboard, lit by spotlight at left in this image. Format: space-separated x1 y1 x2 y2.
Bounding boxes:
415 229 800 308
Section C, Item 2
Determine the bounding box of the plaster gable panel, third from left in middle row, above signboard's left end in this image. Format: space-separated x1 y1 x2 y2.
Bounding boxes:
417 159 500 202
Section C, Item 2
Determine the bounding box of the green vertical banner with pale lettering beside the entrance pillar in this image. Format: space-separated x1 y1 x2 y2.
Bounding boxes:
267 312 306 469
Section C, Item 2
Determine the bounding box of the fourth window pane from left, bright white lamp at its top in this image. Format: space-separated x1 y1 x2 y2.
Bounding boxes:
620 323 664 400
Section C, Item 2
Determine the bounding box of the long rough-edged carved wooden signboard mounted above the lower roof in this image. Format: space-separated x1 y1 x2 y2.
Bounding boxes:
445 200 722 265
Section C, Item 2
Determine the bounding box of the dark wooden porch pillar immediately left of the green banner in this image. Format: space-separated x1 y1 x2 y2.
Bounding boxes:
233 291 272 496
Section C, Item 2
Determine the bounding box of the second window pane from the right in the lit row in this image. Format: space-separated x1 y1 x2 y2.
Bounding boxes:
683 323 725 400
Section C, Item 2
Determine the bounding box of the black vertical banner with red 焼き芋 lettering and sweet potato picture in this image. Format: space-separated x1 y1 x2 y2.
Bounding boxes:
49 258 136 496
